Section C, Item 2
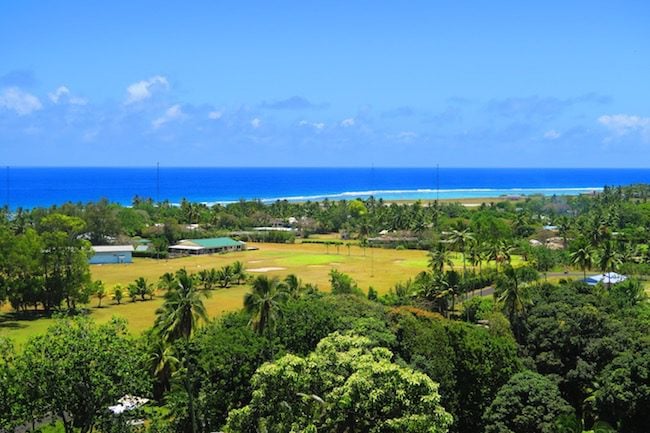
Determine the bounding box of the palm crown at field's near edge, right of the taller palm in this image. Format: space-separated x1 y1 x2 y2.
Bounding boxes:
244 275 287 335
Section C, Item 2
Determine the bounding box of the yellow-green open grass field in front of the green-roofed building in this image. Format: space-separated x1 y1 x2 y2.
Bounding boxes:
0 243 508 346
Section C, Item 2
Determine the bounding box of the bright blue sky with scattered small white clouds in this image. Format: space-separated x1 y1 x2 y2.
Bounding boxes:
0 0 650 167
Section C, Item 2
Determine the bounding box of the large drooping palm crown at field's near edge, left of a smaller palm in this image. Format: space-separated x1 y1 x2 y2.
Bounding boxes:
155 269 209 342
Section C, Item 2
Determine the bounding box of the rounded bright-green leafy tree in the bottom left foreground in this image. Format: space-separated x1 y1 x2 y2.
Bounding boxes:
17 318 149 433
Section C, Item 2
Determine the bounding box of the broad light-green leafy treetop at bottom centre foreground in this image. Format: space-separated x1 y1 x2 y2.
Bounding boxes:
225 333 452 433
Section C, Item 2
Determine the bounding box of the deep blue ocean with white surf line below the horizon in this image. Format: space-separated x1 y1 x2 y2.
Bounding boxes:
0 167 650 209
